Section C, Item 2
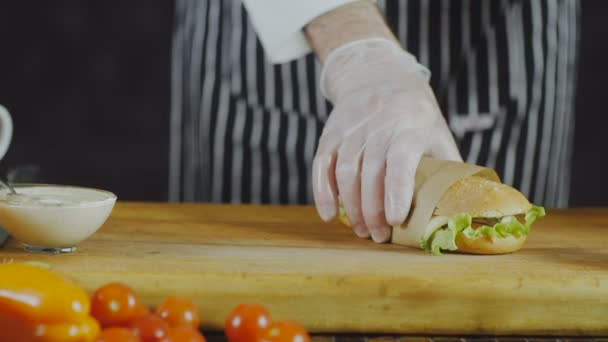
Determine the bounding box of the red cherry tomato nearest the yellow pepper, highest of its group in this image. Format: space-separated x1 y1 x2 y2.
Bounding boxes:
91 283 138 328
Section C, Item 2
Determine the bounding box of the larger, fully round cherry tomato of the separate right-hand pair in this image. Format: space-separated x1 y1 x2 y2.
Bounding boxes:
224 304 270 342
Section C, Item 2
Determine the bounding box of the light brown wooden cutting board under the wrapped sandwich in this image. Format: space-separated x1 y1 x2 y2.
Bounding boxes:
0 203 608 335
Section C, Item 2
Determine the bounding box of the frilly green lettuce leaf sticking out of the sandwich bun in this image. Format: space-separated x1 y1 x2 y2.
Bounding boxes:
421 206 545 255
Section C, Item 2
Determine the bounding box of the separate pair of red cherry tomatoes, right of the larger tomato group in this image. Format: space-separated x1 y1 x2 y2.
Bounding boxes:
225 304 310 342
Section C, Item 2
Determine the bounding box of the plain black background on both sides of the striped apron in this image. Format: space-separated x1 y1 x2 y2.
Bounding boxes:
0 0 608 206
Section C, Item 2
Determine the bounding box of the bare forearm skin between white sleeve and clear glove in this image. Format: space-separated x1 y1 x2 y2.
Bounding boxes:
304 0 396 61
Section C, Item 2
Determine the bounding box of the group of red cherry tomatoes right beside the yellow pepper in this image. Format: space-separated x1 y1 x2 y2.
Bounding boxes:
91 283 205 342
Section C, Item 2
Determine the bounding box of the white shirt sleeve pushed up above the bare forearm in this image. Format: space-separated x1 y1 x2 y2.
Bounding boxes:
243 0 356 64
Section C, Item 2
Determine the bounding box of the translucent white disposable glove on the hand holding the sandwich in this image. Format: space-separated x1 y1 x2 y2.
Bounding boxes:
312 38 462 242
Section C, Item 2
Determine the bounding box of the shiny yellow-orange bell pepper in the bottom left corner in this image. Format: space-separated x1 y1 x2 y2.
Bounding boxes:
0 264 99 342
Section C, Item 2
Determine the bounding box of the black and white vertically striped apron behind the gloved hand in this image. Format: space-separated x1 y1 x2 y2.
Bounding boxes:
169 0 580 207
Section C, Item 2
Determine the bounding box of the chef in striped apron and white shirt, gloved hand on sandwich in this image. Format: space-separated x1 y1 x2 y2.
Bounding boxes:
169 0 579 242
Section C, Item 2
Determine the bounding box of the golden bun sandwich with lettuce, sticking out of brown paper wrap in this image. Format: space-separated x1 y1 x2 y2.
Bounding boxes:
340 176 545 254
